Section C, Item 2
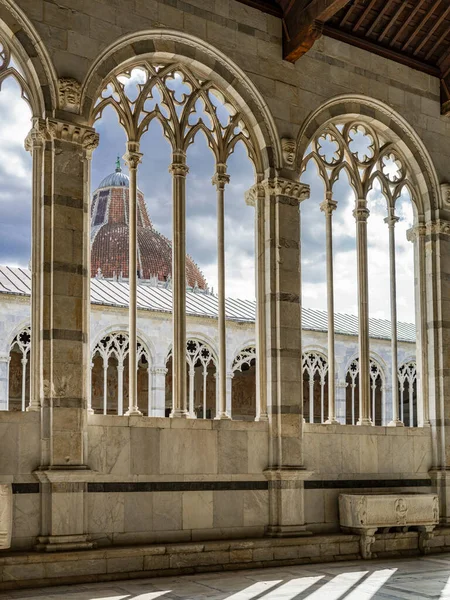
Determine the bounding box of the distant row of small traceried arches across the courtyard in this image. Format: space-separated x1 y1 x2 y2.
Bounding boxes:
9 327 417 427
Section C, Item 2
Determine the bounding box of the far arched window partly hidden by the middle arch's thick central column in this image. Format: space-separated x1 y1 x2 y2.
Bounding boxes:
166 339 218 419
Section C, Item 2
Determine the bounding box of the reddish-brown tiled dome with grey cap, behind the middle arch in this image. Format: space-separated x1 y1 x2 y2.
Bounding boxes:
91 161 207 290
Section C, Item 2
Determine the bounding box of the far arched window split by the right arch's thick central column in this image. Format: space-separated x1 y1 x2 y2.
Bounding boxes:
345 358 386 425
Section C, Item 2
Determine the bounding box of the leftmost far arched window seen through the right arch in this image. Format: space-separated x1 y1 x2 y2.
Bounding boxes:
303 352 328 423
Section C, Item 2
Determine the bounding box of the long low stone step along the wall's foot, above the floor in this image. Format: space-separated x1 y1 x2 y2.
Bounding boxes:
0 527 450 590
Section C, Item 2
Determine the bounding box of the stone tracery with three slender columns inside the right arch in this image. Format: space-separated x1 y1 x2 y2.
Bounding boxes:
302 117 423 425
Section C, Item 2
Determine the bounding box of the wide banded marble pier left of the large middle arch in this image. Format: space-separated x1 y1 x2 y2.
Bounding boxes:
33 111 98 551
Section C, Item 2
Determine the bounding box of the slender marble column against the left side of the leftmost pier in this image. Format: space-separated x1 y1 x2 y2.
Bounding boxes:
25 119 46 411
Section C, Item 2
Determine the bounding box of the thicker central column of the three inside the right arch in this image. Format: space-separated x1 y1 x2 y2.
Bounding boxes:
353 205 373 425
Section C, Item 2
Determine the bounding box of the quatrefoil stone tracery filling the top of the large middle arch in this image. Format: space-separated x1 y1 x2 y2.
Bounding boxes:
93 61 255 163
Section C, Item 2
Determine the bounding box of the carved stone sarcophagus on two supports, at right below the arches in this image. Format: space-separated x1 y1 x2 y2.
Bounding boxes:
339 494 439 558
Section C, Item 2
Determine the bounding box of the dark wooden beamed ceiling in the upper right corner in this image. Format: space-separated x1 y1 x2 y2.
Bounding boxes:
240 0 450 114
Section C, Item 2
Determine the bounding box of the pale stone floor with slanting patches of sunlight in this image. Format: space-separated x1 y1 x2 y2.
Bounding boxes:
4 554 450 600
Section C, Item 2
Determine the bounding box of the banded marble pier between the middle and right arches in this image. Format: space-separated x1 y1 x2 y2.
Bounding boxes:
262 173 311 536
